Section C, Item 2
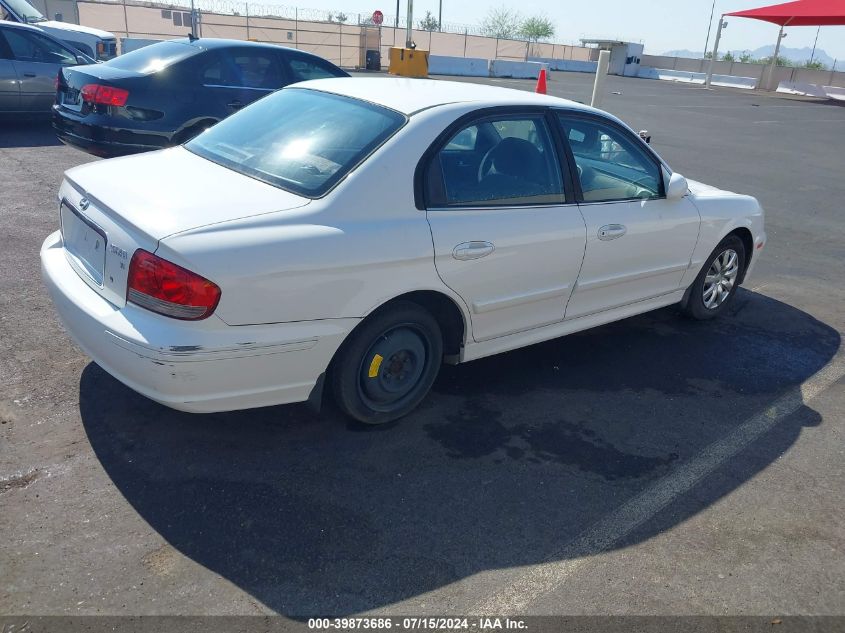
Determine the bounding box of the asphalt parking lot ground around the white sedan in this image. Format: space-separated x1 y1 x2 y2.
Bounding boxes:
0 73 845 618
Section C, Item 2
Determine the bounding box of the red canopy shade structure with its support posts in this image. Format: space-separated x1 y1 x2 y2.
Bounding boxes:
705 0 845 90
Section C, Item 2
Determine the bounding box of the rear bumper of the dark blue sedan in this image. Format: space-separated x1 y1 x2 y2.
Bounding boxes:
52 105 172 157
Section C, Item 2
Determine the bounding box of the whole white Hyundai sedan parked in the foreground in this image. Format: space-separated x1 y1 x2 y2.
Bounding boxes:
41 78 766 424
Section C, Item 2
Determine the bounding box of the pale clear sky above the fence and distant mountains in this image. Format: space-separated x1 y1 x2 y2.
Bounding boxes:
278 0 845 63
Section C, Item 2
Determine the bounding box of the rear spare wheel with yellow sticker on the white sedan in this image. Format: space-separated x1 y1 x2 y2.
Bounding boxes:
329 301 443 424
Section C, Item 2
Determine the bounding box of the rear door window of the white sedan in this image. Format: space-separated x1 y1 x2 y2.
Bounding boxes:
428 115 565 207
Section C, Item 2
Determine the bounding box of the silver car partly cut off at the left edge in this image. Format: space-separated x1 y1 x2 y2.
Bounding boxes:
0 22 94 114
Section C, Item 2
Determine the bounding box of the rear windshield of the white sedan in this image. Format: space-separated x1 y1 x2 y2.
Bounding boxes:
185 88 405 198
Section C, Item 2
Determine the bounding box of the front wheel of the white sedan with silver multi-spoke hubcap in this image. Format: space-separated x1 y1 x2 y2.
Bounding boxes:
682 235 745 321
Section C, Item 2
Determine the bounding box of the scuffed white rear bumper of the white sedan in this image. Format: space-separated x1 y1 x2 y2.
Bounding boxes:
41 231 358 413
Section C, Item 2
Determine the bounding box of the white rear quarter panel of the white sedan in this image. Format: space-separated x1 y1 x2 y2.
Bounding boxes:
158 106 478 327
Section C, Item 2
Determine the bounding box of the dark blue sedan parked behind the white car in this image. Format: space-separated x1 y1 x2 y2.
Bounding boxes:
53 38 348 156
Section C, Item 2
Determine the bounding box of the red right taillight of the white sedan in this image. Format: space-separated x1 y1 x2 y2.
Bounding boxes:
126 249 220 321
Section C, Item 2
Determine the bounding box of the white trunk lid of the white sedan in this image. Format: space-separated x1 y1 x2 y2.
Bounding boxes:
59 147 310 306
